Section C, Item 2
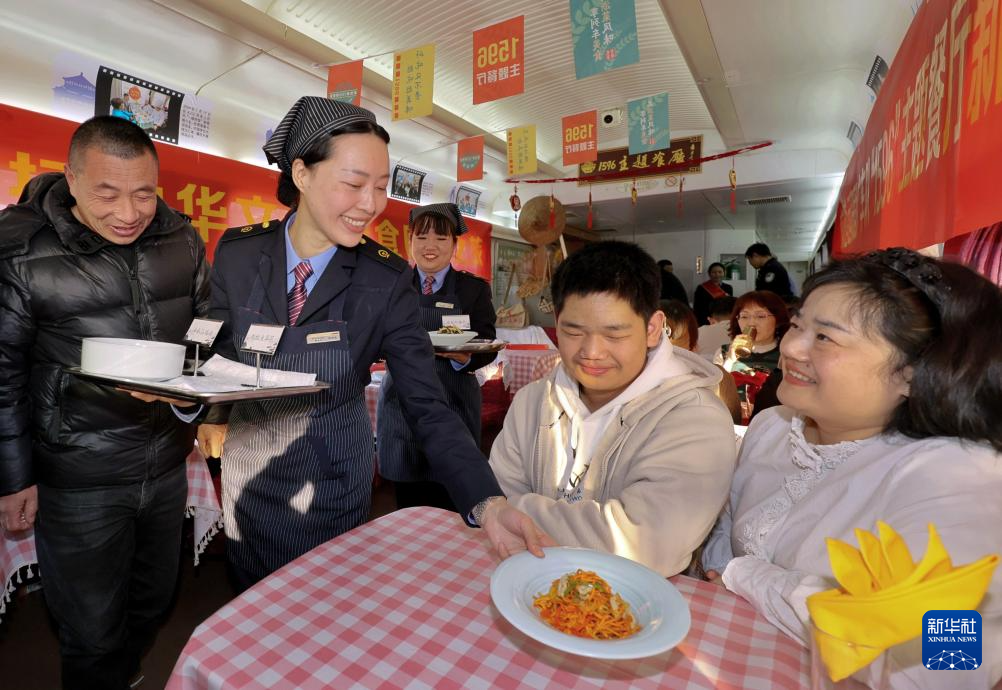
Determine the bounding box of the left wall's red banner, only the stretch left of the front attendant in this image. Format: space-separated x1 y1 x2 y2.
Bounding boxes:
0 104 288 256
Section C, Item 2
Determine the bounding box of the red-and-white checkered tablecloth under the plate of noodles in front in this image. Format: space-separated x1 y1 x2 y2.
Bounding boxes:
167 508 810 690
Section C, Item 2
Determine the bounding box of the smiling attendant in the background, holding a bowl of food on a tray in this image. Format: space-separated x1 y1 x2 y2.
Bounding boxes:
376 203 497 510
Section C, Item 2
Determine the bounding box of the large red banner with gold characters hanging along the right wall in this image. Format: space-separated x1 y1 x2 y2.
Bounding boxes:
834 0 1002 254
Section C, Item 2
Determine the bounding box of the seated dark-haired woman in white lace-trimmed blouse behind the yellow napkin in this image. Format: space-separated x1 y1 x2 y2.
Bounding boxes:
702 249 1002 688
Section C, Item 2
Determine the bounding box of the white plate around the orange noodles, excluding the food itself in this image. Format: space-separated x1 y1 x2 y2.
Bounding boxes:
491 547 690 659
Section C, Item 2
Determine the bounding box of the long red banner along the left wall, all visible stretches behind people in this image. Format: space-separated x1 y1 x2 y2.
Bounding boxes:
0 104 491 280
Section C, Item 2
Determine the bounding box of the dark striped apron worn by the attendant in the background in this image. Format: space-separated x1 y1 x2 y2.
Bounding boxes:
376 284 481 482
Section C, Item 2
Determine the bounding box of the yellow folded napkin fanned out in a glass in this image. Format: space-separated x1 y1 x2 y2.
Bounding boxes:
808 521 999 681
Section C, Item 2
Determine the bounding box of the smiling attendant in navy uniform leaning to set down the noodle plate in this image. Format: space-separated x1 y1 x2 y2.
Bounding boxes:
199 96 549 587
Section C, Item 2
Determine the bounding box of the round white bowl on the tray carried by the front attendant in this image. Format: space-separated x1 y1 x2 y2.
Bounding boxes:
80 337 184 381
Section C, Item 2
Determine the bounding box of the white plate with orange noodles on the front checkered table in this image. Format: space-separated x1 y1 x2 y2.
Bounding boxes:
491 547 690 659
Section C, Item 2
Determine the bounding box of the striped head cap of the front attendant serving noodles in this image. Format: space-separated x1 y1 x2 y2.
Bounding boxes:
262 96 377 172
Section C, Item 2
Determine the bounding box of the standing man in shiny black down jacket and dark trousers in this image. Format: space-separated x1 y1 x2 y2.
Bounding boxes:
0 116 209 690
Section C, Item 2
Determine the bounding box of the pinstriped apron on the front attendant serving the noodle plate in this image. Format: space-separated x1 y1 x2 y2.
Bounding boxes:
222 268 374 577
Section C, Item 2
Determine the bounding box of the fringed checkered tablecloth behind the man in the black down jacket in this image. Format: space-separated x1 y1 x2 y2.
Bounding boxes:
0 448 222 617
